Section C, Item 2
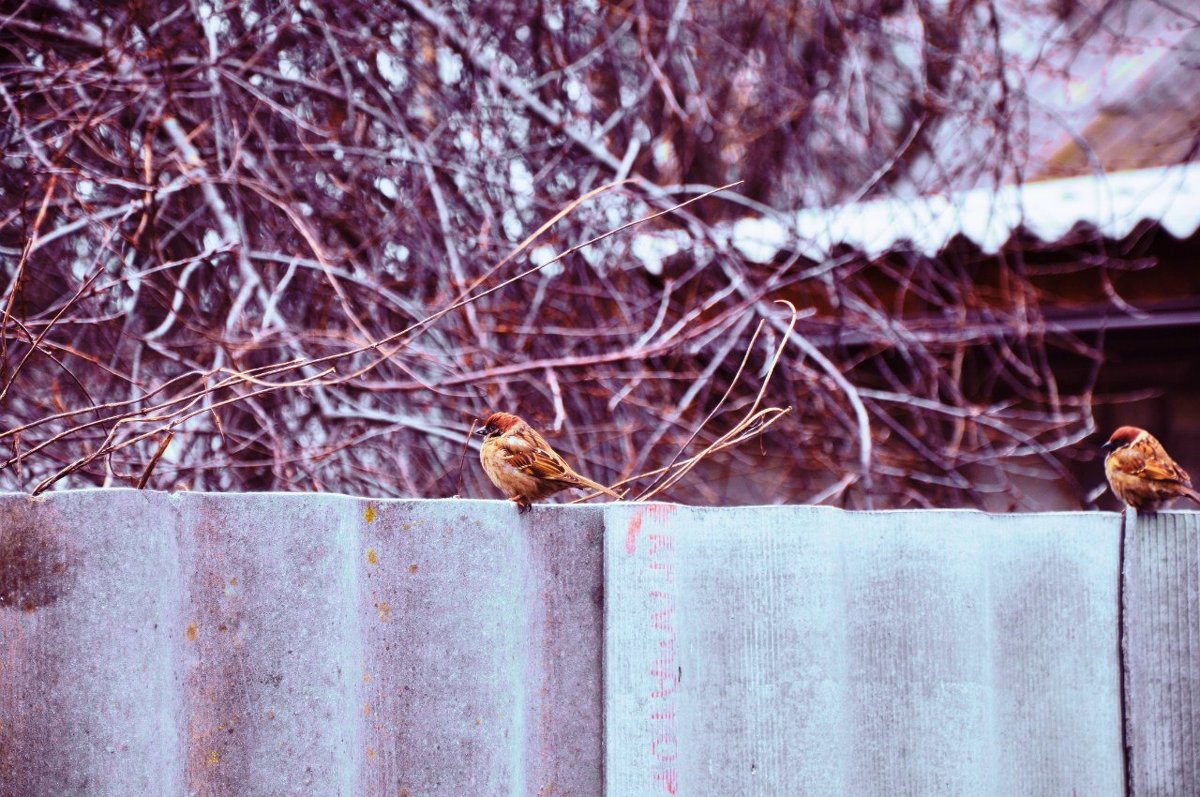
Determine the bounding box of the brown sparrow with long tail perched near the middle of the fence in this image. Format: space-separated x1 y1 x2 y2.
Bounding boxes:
475 413 620 511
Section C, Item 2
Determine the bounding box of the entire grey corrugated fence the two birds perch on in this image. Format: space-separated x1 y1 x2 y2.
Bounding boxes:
0 490 1200 797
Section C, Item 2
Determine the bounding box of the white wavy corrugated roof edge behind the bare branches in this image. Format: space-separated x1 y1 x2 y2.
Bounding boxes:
731 162 1200 263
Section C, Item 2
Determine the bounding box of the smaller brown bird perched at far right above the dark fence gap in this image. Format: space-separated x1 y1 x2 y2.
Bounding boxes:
1104 426 1200 513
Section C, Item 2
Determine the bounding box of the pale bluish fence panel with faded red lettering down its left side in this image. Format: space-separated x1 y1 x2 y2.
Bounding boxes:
605 505 1124 796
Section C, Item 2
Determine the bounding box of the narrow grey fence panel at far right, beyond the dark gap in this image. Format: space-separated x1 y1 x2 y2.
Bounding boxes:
1124 513 1200 797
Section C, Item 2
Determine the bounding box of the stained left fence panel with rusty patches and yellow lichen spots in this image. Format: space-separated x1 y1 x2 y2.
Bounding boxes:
0 491 602 797
